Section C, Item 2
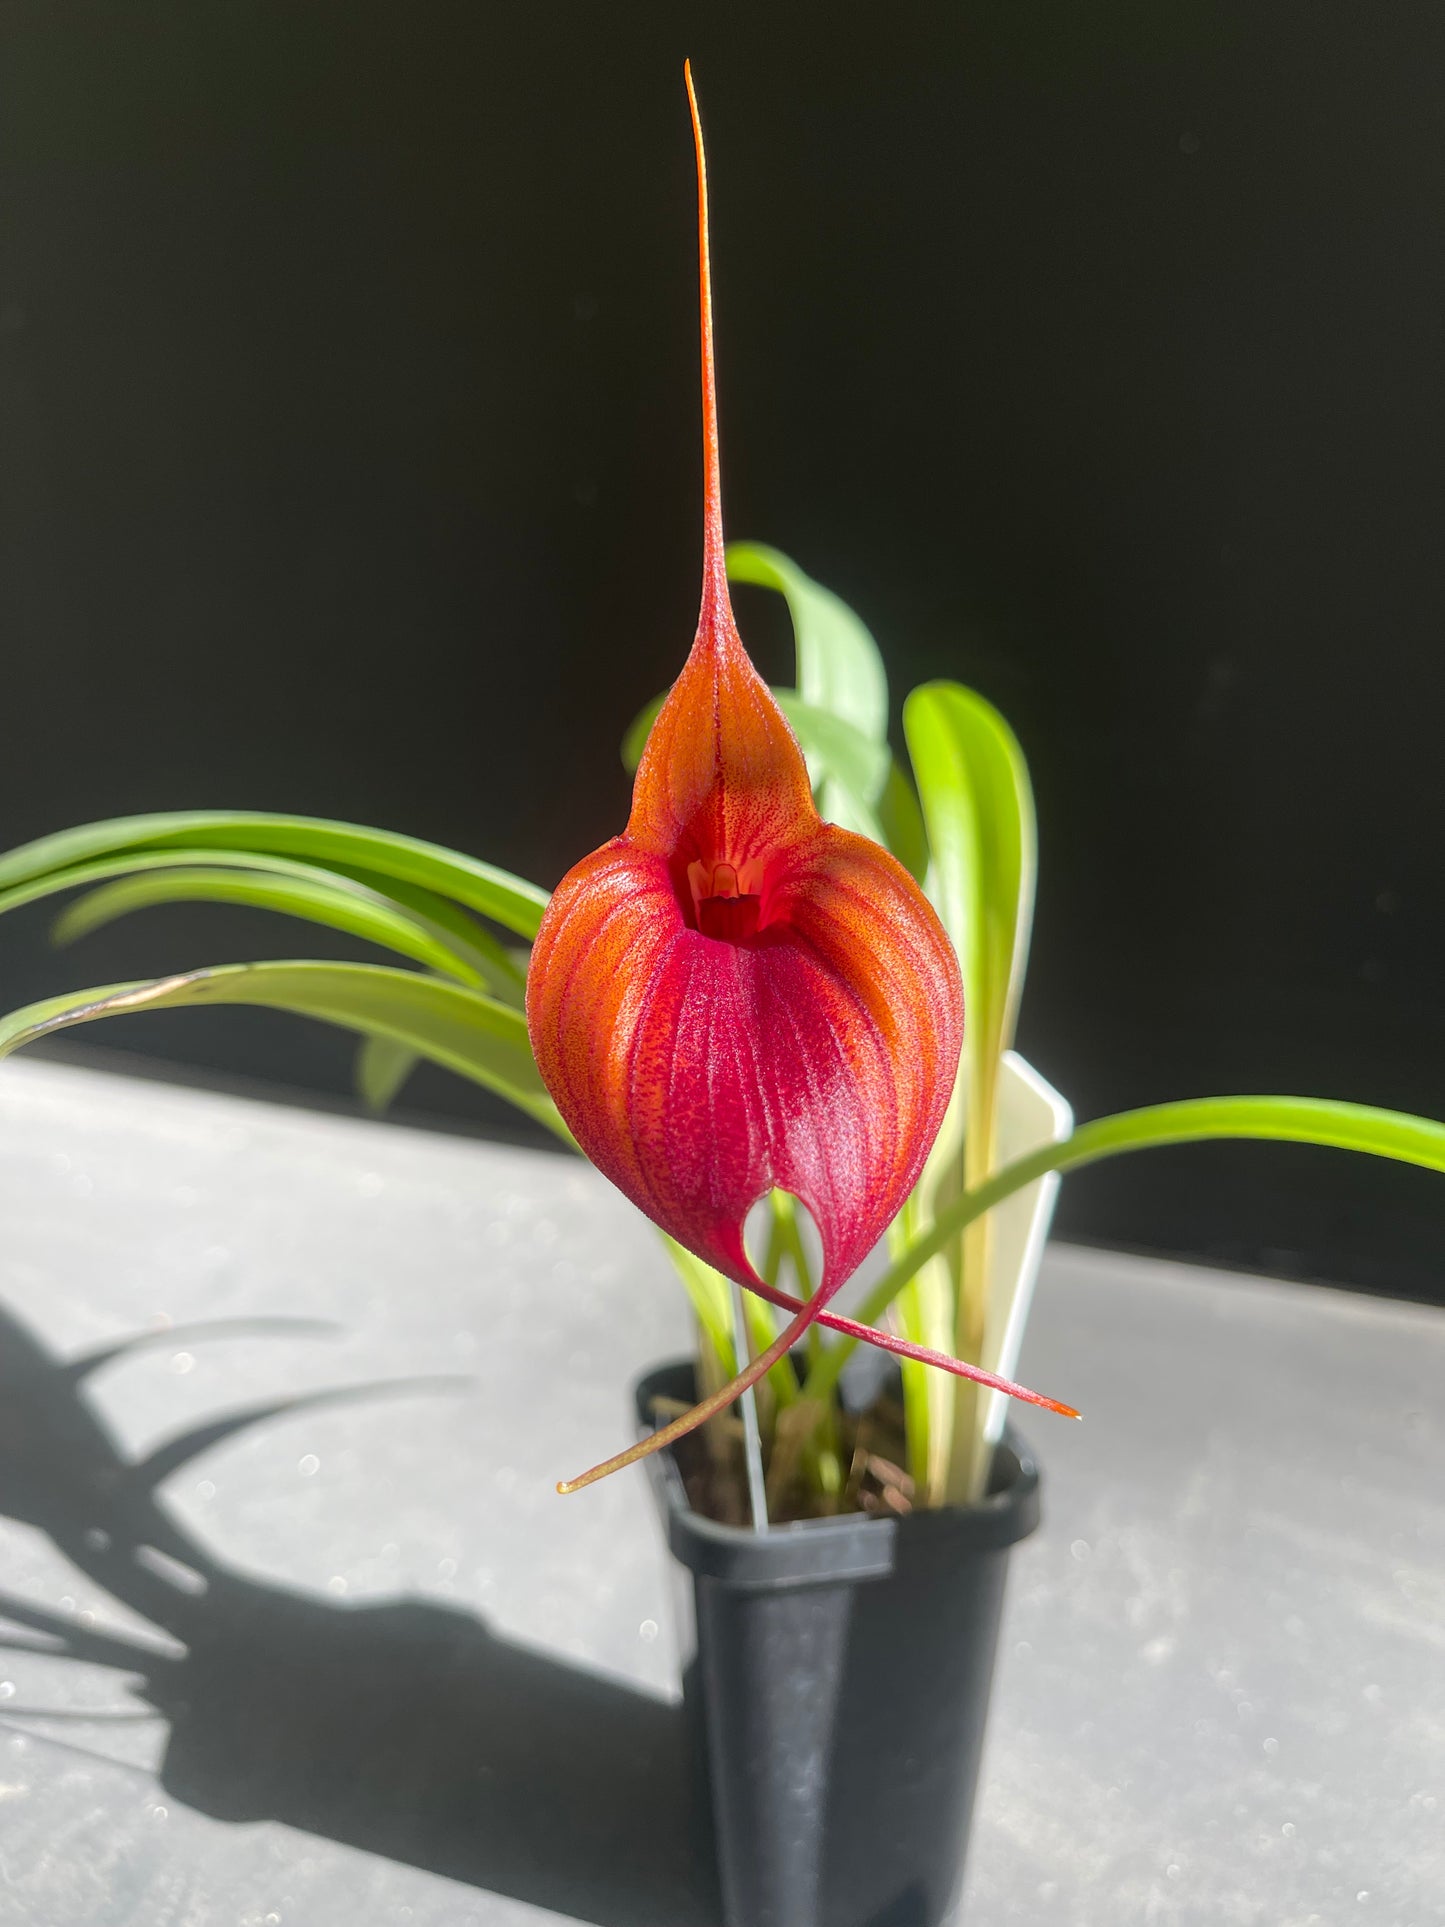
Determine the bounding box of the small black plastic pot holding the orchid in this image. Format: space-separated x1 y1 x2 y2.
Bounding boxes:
636 1364 1038 1927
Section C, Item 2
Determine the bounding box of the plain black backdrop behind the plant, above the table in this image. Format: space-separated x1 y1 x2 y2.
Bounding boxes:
0 0 1445 1297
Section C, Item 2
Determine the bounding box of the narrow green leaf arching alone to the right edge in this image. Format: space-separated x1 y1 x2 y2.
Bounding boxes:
803 1096 1445 1399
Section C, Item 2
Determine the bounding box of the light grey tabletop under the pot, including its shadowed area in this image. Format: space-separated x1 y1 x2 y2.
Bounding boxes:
0 1062 1445 1927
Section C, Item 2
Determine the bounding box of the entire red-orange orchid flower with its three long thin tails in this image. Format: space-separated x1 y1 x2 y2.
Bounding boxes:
526 71 1067 1491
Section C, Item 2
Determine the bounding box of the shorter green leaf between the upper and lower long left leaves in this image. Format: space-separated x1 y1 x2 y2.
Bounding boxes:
54 858 487 985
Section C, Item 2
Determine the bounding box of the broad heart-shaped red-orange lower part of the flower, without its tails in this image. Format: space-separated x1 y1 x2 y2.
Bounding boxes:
528 825 961 1295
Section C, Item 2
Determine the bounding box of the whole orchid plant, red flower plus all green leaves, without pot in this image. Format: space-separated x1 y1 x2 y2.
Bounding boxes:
0 75 1445 1505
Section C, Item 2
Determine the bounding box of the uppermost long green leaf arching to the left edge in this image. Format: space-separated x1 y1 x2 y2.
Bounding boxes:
0 809 547 938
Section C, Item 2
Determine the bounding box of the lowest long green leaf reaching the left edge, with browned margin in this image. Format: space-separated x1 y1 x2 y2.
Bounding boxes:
0 964 572 1143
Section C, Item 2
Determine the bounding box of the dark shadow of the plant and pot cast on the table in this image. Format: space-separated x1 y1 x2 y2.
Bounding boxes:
0 1310 719 1927
